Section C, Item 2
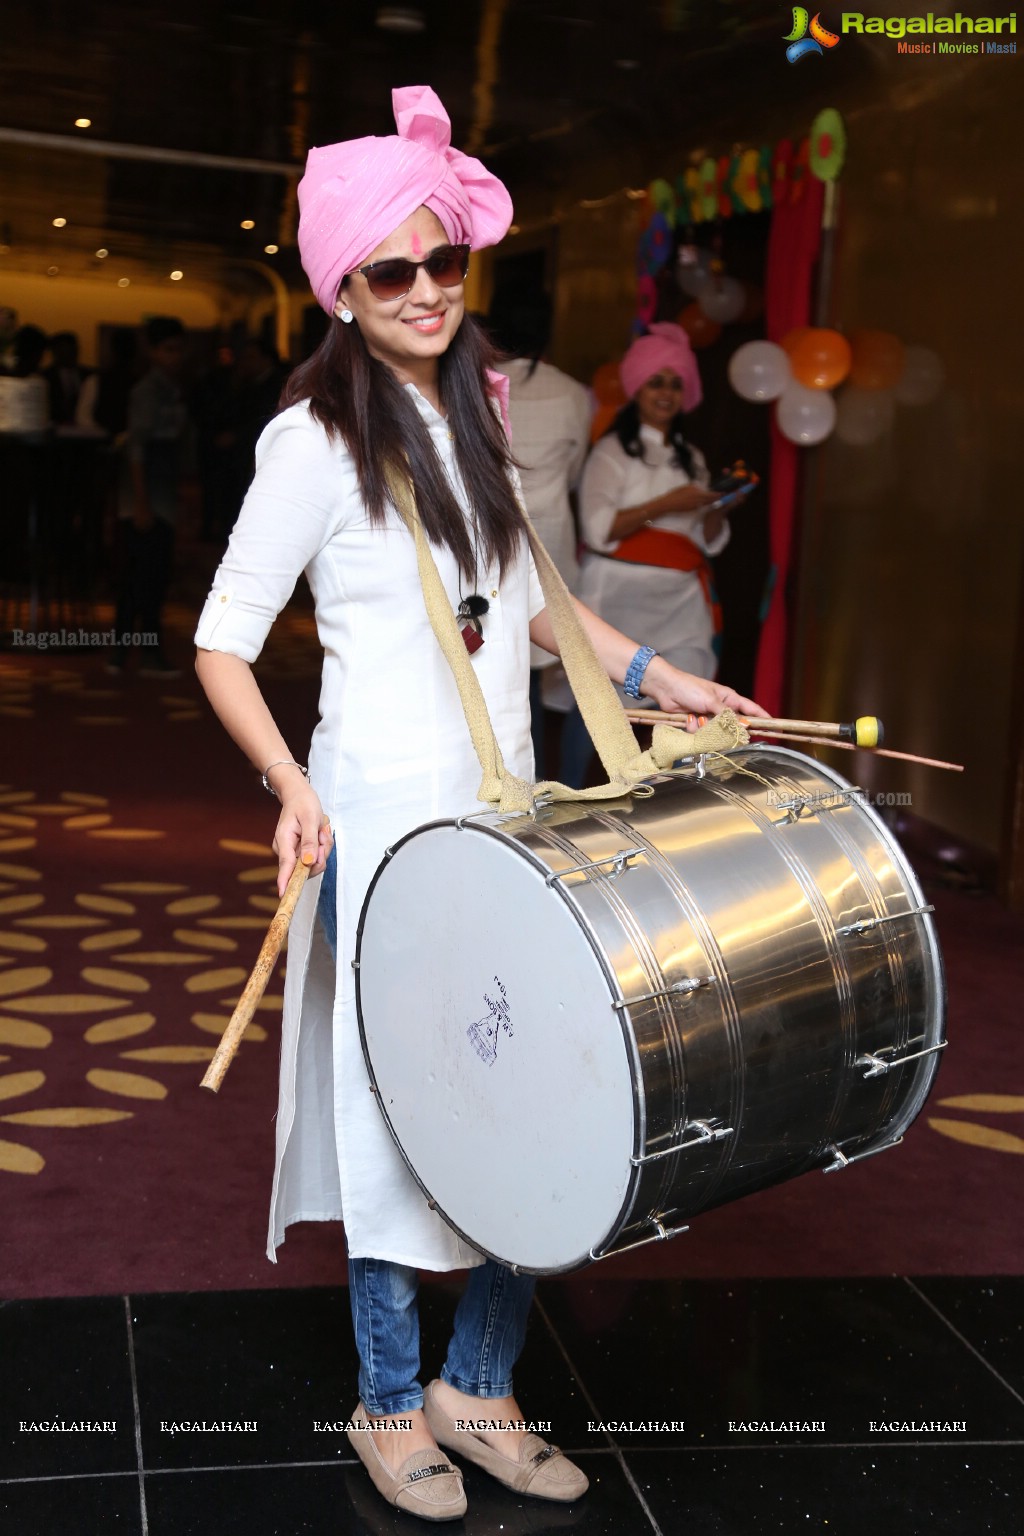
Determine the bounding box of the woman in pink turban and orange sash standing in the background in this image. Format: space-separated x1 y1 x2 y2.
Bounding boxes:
567 323 729 783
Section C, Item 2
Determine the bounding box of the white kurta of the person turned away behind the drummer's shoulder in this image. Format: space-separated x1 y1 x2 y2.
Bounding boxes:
499 358 591 667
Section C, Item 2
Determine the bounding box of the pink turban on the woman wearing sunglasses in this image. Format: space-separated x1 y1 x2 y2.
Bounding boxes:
298 86 513 315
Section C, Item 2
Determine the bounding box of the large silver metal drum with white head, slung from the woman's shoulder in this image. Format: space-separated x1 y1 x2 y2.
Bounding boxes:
356 746 944 1273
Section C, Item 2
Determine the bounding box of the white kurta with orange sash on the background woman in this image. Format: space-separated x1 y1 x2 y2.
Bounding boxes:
576 427 729 677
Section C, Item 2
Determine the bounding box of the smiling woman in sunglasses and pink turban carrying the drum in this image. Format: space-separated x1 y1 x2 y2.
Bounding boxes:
197 88 755 1519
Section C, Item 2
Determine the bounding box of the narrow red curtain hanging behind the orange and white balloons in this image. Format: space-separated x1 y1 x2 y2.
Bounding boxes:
754 143 824 714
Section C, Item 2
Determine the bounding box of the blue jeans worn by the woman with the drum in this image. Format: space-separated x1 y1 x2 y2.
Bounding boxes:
318 848 536 1418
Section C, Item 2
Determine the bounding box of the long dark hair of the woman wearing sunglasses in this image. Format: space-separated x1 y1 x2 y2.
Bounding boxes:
281 315 524 578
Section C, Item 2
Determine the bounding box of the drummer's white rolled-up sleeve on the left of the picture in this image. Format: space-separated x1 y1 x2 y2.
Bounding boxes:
195 406 350 662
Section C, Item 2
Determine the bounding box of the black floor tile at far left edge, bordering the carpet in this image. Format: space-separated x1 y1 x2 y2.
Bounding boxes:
0 1296 138 1481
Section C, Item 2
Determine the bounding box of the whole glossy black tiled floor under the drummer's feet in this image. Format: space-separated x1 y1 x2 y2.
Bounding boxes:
0 1270 1024 1536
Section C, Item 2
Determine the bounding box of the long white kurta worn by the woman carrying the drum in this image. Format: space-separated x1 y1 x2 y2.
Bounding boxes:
197 386 543 1270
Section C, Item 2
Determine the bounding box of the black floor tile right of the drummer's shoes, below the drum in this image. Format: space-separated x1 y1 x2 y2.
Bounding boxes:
542 1272 1024 1447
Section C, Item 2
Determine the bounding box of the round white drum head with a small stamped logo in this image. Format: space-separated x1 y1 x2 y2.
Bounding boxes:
356 822 642 1273
